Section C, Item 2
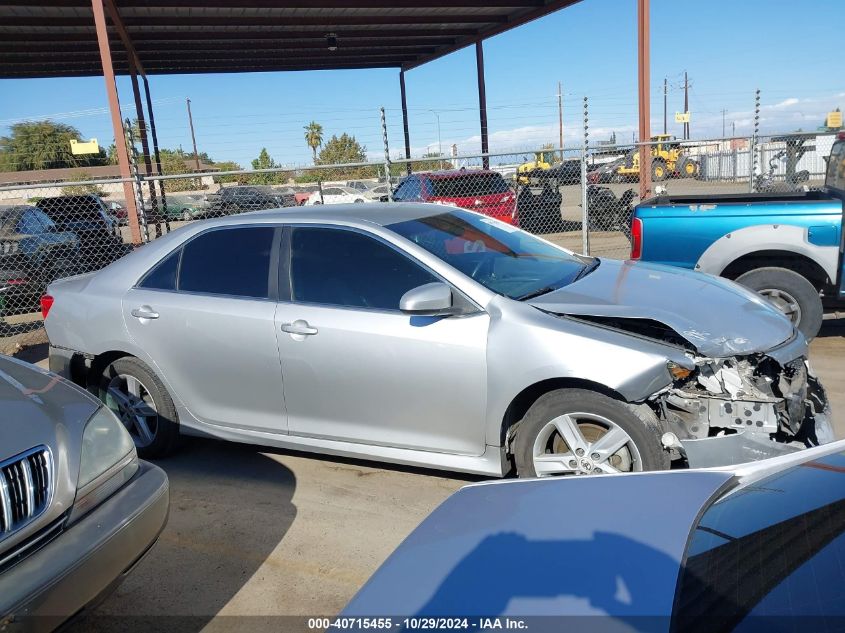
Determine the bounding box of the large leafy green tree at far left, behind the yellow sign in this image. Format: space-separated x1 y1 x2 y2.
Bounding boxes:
0 120 108 171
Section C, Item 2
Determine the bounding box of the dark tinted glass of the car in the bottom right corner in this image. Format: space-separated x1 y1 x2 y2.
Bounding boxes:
672 453 845 633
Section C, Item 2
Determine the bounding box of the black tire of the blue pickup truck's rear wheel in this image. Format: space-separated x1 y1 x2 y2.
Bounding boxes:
736 267 824 339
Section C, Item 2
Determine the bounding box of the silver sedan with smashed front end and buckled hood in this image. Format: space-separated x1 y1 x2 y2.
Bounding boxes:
44 204 833 476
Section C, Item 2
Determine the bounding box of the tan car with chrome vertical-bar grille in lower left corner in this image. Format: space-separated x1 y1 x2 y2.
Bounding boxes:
0 356 169 631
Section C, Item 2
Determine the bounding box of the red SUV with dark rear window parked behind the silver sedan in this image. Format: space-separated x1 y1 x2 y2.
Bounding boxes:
393 169 518 225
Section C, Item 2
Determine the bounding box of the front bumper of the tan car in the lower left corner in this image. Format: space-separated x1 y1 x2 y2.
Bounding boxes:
0 462 170 631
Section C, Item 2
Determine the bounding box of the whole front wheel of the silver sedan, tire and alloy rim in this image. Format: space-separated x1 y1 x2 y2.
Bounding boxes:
514 389 669 477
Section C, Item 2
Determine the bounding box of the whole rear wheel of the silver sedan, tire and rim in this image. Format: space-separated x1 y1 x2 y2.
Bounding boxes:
100 357 179 458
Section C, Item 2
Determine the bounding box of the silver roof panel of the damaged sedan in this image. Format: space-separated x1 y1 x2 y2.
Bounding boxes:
202 202 456 226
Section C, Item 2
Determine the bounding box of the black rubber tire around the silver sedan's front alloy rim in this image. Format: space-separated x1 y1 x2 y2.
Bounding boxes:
513 389 670 477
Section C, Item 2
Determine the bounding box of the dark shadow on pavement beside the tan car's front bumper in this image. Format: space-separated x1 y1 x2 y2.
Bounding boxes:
67 438 296 633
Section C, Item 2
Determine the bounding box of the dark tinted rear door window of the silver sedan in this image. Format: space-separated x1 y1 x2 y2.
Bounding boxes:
178 227 275 299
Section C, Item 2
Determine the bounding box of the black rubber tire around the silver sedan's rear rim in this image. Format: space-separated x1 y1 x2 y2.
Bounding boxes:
100 356 179 459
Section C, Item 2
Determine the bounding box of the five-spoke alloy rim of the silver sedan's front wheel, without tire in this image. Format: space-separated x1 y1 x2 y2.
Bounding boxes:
533 413 643 477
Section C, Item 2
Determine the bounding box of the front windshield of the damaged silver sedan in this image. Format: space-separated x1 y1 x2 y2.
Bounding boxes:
386 210 597 299
